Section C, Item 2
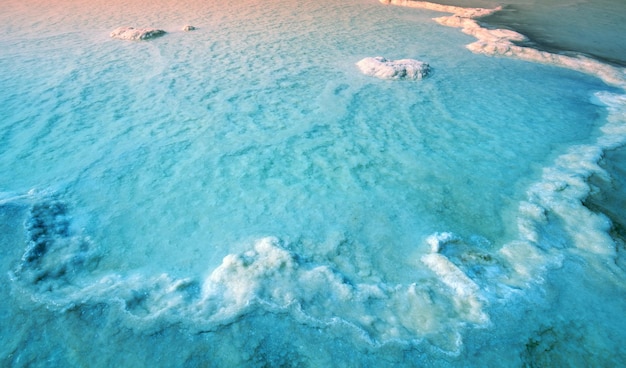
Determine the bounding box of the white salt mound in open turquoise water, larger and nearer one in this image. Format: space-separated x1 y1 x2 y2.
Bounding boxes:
356 56 430 80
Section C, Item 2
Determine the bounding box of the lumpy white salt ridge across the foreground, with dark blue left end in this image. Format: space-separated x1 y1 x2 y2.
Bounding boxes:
10 196 487 354
